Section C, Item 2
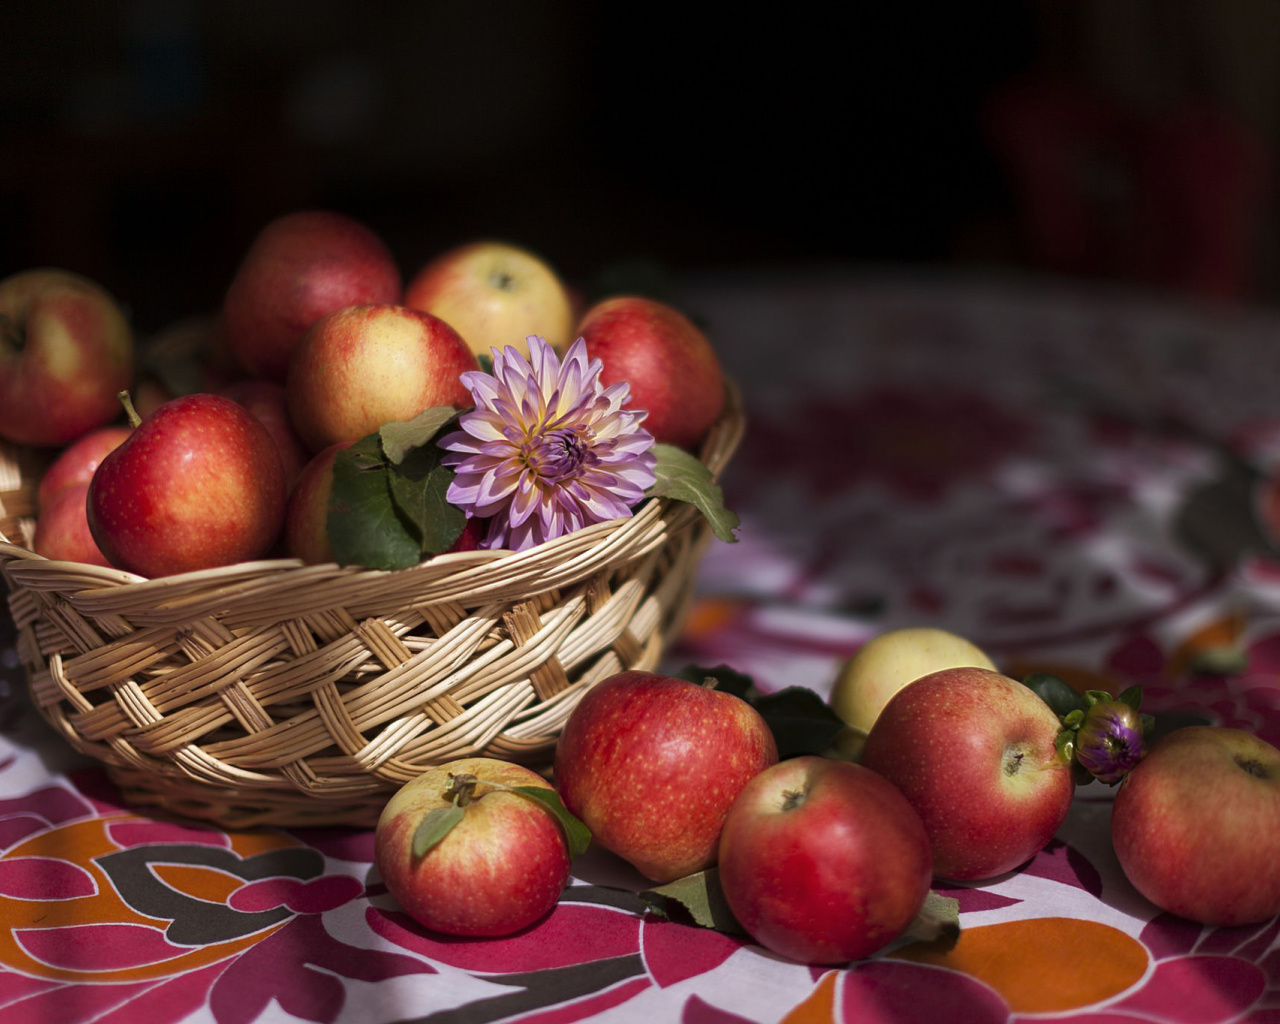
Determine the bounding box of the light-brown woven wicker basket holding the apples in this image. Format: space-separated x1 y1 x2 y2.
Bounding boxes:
0 388 744 828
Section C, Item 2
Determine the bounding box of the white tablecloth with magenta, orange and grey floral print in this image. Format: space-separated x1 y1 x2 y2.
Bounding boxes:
0 273 1280 1024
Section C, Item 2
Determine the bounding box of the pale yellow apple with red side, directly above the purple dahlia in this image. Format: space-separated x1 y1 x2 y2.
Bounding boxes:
404 242 573 357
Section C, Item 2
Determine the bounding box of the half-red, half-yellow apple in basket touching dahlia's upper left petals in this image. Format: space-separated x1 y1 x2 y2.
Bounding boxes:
285 299 480 452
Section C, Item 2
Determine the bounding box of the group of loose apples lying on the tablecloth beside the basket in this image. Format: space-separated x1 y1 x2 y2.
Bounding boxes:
375 628 1280 964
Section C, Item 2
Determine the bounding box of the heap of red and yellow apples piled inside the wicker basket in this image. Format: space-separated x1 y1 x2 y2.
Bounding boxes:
0 210 724 577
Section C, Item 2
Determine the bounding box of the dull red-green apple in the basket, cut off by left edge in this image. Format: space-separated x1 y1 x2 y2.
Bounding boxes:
0 268 134 445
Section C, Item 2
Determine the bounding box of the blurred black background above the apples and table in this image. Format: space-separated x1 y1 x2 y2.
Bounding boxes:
0 0 1280 329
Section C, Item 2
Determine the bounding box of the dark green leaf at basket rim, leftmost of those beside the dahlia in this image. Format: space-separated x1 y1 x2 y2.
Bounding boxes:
326 434 421 568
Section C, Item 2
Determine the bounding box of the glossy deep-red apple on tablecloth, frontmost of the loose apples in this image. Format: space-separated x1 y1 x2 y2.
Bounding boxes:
719 756 933 964
